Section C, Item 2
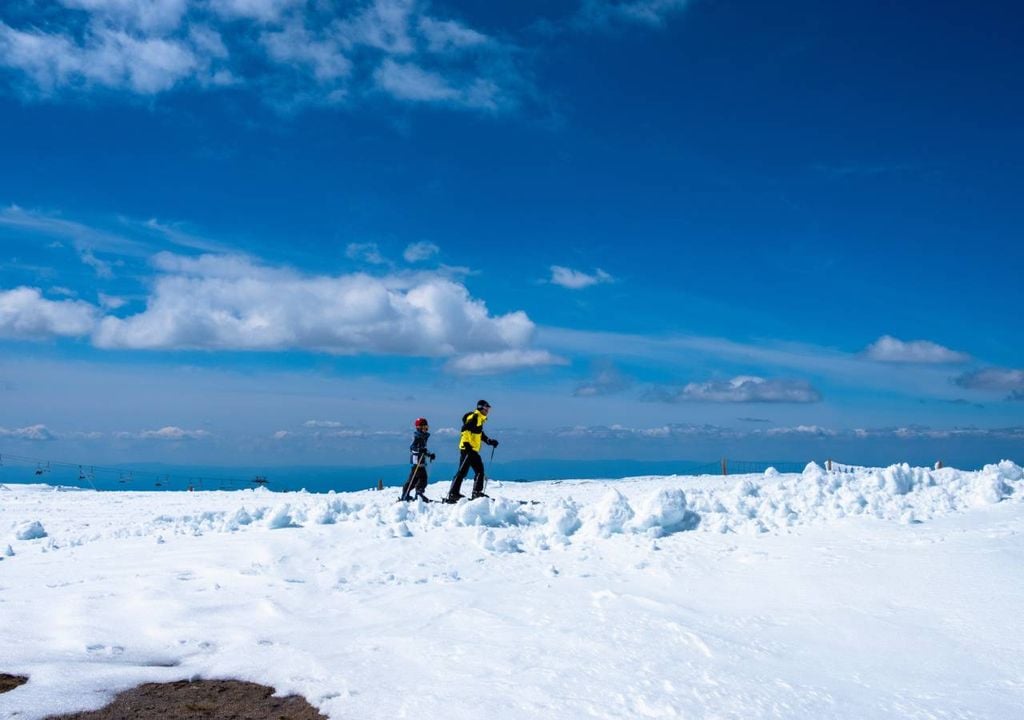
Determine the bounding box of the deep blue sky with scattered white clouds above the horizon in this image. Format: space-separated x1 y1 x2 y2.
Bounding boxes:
0 0 1024 465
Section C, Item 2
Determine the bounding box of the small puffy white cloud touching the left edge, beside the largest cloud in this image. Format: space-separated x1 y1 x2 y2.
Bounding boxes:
0 287 98 339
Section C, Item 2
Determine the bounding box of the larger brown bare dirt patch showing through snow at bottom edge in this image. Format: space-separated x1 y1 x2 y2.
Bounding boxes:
41 680 327 720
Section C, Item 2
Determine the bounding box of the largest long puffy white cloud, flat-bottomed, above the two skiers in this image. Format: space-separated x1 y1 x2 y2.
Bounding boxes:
93 253 534 356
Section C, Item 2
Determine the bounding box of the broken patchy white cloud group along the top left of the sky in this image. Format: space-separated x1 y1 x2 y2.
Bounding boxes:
0 0 528 112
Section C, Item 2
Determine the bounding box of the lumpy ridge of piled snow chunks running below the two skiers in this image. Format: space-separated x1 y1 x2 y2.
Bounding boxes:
0 461 1024 552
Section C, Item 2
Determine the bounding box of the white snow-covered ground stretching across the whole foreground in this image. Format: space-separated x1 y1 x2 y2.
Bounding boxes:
0 462 1024 720
